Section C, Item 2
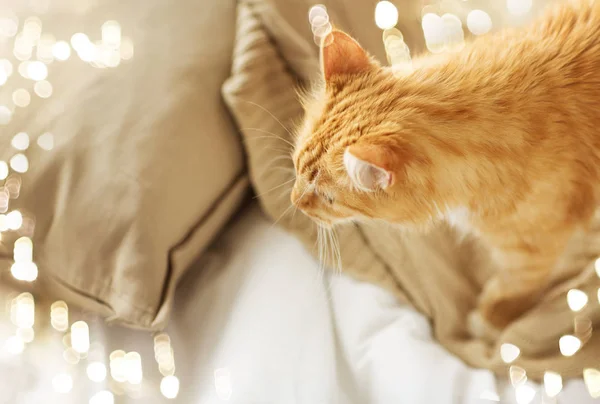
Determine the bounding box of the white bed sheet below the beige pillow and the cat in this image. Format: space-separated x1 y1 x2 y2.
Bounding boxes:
0 206 596 404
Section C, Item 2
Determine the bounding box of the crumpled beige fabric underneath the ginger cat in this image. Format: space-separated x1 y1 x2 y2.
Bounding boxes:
223 0 600 380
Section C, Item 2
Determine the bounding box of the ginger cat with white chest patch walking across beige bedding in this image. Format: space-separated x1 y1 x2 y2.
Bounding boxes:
291 0 600 332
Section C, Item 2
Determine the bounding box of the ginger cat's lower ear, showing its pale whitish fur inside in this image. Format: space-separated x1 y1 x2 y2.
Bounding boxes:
344 145 394 192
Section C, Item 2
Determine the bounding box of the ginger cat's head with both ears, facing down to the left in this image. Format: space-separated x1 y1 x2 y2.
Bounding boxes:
291 31 432 226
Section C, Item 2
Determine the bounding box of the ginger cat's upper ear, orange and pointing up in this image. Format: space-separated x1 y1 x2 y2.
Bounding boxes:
321 30 373 81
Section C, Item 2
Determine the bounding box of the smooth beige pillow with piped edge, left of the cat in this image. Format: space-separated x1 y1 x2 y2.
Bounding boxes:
0 0 248 328
